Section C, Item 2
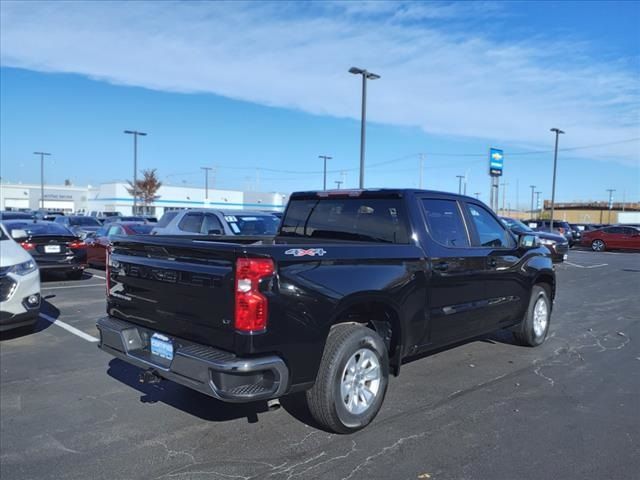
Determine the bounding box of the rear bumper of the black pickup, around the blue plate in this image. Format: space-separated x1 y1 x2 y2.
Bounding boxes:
96 317 289 403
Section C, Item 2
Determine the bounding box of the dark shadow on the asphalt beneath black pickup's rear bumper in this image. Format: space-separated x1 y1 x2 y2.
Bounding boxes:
107 358 270 423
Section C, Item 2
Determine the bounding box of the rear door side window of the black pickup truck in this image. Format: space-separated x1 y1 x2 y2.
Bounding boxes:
422 198 469 247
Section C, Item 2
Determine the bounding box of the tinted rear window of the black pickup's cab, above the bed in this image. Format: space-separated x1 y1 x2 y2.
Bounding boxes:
280 198 409 243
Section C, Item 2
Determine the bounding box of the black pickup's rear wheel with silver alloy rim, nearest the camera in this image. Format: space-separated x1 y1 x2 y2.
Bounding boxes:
306 324 389 433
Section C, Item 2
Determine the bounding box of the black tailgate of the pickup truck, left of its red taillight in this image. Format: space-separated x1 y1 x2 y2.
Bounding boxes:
108 237 242 350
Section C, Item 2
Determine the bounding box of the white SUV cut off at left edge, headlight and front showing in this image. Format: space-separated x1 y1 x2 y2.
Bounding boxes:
0 224 40 332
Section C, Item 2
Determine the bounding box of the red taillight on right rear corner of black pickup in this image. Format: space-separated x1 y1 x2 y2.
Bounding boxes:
235 258 275 332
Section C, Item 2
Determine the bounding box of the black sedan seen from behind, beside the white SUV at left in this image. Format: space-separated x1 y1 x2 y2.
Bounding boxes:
3 220 87 280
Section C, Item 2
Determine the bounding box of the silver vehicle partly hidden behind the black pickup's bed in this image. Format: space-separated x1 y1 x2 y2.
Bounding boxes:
152 209 280 236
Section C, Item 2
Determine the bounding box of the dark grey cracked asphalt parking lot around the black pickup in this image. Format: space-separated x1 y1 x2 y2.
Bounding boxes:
0 250 640 480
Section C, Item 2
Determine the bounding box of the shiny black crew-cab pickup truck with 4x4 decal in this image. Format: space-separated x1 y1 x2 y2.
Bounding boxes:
97 189 555 433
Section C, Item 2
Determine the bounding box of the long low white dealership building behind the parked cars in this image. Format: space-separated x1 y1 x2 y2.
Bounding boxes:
0 182 288 217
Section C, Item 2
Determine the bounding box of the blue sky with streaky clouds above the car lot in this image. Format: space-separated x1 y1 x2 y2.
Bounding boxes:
0 2 640 206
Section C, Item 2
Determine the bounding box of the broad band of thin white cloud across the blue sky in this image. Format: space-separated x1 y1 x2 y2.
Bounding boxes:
0 2 640 165
